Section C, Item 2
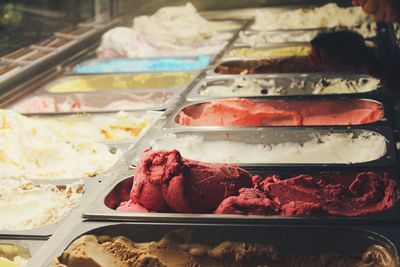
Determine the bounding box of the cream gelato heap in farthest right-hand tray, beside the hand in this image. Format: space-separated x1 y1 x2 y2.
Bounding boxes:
252 3 372 31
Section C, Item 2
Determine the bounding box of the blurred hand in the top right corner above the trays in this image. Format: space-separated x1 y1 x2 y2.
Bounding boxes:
352 0 400 23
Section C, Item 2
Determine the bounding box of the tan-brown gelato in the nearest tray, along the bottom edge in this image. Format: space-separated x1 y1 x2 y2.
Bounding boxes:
53 230 396 267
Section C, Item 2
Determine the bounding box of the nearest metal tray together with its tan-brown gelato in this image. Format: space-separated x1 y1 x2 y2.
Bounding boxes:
32 222 398 266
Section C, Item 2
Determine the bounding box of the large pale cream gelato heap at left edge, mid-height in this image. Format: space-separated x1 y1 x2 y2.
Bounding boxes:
0 110 122 179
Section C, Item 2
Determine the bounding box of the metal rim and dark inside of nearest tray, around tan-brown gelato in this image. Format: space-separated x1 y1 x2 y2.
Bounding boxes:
30 222 399 266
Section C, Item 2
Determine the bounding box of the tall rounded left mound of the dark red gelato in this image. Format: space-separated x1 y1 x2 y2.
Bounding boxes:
130 150 252 213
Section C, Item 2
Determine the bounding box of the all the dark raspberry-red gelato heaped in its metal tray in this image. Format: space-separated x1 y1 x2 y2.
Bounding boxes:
117 150 398 217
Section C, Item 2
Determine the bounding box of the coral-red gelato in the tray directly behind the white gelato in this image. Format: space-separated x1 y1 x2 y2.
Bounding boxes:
176 98 383 127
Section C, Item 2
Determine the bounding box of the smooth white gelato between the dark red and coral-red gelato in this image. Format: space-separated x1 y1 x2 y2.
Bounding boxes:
150 131 387 164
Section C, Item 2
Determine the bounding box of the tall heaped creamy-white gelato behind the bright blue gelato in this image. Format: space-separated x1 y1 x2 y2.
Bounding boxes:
97 3 233 58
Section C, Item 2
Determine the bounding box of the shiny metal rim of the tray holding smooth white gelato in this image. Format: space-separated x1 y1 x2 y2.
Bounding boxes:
130 125 396 169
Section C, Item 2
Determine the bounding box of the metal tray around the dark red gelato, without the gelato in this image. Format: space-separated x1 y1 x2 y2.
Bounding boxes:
82 168 400 225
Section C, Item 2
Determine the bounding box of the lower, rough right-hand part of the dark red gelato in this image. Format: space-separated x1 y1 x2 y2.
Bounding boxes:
216 172 397 216
